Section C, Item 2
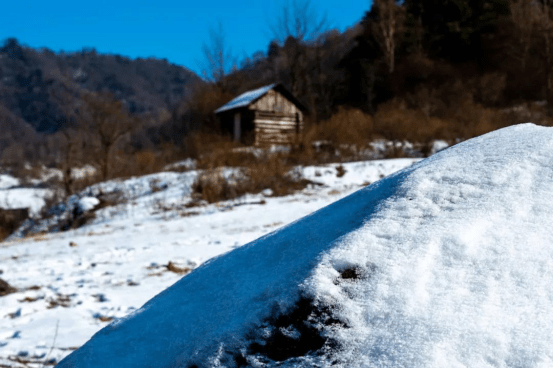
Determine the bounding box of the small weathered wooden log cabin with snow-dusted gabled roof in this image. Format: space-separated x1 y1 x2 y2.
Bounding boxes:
215 84 305 147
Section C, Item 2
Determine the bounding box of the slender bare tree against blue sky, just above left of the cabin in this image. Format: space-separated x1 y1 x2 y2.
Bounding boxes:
199 21 236 87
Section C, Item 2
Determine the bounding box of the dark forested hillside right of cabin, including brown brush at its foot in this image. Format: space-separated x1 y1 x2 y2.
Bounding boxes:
185 0 553 147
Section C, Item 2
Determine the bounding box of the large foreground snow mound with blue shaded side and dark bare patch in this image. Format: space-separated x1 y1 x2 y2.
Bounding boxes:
58 124 553 368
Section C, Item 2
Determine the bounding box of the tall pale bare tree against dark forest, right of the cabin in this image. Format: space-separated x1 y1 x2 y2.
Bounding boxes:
371 0 405 73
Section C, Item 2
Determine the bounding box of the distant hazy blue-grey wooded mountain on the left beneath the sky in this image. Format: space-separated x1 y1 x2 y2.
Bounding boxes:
0 39 201 133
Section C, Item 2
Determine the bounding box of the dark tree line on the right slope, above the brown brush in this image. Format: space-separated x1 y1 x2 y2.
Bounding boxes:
180 0 553 129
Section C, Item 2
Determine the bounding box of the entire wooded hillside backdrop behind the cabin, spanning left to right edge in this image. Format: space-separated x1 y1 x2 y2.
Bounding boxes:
0 0 553 183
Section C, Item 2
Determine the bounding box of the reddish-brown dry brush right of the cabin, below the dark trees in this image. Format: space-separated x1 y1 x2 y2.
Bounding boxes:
298 78 553 164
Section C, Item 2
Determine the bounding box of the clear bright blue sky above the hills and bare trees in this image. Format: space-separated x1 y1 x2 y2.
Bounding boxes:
0 0 370 72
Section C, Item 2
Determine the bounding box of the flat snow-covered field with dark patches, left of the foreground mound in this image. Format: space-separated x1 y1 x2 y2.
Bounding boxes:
0 159 418 367
